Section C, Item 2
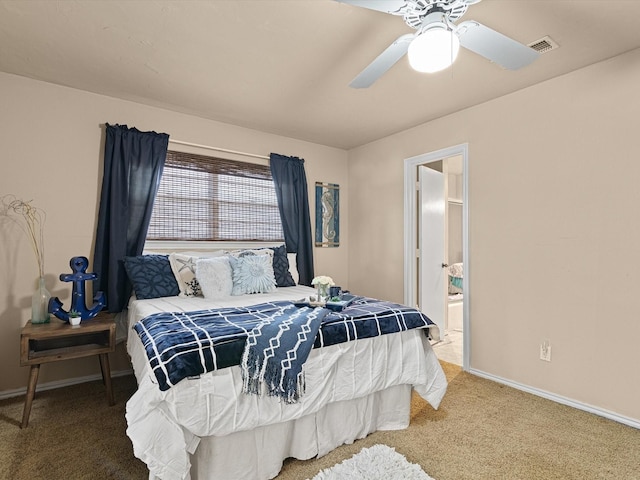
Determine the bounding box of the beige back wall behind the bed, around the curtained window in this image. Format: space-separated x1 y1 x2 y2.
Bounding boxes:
0 73 349 395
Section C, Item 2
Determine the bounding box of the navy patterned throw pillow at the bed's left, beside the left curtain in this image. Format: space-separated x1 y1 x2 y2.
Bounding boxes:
124 255 180 300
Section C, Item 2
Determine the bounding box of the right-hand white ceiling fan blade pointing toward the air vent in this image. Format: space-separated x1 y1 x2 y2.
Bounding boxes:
456 21 540 70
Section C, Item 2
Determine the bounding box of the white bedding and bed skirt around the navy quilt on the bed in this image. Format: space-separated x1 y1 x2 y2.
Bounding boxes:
126 248 447 480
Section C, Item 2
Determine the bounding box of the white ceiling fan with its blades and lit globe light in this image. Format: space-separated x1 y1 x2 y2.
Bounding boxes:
337 0 539 88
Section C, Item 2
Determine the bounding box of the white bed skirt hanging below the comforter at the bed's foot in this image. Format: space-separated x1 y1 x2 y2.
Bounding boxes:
162 385 411 480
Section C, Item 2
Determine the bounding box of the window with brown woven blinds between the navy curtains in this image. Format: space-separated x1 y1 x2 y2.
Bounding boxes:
147 151 284 242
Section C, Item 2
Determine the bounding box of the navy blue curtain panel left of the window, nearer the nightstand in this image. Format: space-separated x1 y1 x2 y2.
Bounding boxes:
93 124 169 312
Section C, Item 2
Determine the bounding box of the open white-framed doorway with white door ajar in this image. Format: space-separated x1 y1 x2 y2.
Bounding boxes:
405 144 470 370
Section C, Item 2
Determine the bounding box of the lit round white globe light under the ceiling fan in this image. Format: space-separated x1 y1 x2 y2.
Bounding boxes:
407 25 460 73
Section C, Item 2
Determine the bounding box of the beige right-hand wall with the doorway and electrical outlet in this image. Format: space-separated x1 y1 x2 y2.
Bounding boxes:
349 50 640 420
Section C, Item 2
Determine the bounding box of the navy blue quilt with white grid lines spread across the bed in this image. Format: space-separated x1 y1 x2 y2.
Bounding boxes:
133 297 434 394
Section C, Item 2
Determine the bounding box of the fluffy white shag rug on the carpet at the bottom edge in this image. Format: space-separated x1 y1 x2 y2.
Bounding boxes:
313 445 433 480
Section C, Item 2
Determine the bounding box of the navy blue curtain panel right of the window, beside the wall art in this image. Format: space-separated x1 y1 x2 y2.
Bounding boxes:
269 153 313 286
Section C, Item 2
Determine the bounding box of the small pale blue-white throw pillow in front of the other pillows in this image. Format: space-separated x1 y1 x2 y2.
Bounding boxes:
227 255 276 295
